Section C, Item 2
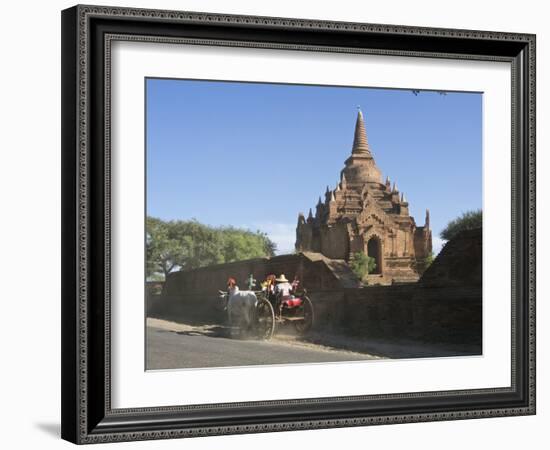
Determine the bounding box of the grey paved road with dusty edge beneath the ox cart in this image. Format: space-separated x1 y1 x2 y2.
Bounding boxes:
147 320 377 369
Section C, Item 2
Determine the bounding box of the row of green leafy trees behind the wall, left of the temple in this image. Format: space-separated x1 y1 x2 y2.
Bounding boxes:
146 217 276 279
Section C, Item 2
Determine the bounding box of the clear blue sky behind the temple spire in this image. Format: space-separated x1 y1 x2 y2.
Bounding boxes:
146 79 482 252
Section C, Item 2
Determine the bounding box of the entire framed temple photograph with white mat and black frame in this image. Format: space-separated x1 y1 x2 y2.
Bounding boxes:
62 6 535 443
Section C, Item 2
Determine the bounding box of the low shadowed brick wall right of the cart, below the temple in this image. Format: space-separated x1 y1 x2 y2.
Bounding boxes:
310 285 482 344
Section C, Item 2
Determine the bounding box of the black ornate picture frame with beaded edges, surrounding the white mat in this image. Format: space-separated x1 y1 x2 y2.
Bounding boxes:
62 6 535 444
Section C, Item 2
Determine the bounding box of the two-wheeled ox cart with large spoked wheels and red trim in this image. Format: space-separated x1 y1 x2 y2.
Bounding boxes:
220 289 314 340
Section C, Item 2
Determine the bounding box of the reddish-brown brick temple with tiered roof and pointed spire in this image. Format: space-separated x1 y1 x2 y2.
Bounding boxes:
296 110 432 284
